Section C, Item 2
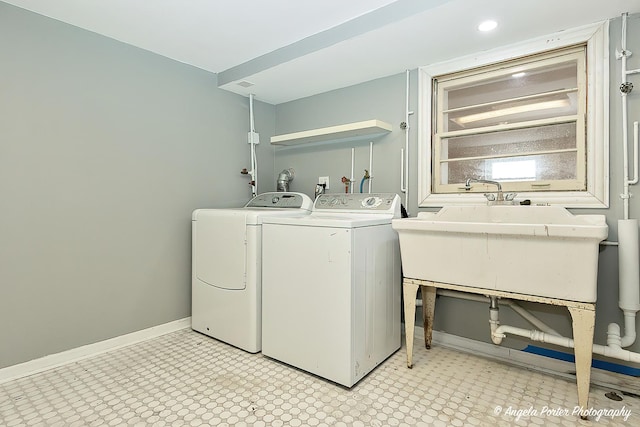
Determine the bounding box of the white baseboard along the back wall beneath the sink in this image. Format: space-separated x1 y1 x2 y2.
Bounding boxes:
414 326 640 395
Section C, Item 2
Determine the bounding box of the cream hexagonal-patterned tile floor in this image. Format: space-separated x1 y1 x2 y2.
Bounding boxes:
0 329 640 427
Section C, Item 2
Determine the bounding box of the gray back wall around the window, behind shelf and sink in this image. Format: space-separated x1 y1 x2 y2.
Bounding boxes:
275 15 640 363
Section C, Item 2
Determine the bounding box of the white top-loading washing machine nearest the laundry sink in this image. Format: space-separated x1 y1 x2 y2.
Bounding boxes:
262 193 402 387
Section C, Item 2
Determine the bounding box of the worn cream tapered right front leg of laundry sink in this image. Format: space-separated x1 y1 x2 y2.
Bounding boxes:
567 306 596 420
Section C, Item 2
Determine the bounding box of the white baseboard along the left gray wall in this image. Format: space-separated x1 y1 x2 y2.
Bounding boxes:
0 317 191 384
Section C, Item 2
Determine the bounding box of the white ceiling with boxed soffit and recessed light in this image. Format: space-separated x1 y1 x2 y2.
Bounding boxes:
3 0 640 104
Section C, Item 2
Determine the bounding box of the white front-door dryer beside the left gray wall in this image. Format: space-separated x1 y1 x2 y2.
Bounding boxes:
191 192 313 353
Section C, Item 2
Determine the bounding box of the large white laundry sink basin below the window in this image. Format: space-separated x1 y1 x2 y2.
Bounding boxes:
392 205 608 302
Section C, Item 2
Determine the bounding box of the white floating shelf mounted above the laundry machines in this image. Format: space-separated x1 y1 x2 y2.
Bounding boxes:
271 120 391 146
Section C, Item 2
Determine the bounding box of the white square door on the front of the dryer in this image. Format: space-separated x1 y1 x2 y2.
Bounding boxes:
192 210 247 290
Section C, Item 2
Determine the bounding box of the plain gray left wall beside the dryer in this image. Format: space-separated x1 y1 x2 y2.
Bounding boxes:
0 3 275 368
